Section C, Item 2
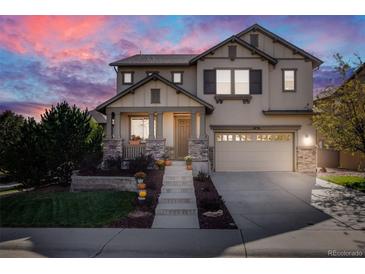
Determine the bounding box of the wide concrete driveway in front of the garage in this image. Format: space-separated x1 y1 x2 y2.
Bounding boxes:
212 172 365 257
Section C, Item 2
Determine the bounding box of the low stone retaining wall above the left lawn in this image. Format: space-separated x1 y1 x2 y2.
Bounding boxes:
71 175 138 192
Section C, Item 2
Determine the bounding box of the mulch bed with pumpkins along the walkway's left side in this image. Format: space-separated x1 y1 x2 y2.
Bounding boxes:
109 170 164 228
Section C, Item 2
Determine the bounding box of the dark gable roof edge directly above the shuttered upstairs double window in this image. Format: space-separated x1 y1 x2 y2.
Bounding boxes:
190 35 278 65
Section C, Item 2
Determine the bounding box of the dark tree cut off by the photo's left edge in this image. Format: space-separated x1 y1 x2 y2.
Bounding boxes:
0 110 24 172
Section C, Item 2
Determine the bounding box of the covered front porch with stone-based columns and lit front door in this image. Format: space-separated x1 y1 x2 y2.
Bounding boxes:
104 107 208 163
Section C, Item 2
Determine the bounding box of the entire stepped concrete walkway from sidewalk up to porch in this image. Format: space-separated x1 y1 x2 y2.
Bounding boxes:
152 161 199 228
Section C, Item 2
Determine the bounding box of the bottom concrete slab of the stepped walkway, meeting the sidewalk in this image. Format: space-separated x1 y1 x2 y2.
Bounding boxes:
152 215 199 228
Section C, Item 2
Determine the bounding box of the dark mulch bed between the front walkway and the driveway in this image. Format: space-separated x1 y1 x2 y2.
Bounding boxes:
194 177 237 229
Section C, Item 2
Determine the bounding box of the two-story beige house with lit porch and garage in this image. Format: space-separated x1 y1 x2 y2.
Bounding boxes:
96 24 322 173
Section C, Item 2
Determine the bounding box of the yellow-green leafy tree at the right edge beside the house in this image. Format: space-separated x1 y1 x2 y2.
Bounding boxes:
313 54 365 153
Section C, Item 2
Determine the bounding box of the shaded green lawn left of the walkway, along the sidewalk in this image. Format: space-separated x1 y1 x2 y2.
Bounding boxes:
0 192 137 227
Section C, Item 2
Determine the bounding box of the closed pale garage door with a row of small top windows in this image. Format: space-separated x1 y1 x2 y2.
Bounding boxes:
215 132 293 171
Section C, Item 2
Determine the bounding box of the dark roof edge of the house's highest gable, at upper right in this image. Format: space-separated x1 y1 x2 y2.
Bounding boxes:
236 24 323 67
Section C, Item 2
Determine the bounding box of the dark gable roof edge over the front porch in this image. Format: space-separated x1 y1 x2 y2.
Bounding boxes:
96 73 214 113
